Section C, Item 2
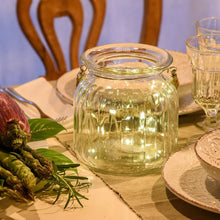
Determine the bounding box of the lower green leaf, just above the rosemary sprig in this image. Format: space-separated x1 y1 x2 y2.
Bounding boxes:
37 148 73 168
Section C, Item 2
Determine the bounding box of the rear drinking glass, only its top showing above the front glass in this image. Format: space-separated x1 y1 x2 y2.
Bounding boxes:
196 17 220 34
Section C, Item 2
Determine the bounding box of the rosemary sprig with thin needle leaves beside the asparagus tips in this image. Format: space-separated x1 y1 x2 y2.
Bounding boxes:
35 163 91 209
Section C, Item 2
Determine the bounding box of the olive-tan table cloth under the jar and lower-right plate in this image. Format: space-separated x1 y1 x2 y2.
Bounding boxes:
58 113 220 220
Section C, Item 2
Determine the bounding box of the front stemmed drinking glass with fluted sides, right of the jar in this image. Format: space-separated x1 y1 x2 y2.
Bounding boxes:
186 34 220 131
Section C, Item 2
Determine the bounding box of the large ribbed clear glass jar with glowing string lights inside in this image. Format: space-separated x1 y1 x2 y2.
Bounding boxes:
73 43 179 175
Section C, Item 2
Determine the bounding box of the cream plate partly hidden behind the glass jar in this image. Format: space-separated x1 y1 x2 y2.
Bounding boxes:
56 51 201 115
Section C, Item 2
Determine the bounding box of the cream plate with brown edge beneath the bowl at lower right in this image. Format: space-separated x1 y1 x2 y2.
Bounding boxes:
162 145 220 213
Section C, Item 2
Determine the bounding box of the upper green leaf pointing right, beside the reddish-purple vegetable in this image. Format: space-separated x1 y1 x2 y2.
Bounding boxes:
28 118 65 141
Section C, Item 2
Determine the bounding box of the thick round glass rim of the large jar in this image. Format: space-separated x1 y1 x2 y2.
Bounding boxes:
80 43 173 79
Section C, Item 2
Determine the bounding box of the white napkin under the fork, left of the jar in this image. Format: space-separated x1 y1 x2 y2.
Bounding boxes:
15 77 73 127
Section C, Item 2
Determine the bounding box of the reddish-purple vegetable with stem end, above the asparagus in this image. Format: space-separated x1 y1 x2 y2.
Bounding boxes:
0 91 31 149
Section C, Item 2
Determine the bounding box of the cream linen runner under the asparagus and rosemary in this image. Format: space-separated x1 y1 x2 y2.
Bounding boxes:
0 138 139 220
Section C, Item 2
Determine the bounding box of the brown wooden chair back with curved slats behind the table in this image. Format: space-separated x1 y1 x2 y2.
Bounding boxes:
17 0 162 80
